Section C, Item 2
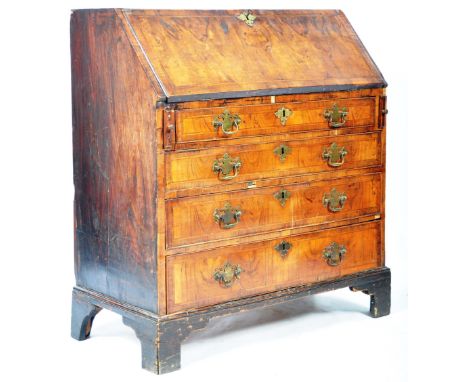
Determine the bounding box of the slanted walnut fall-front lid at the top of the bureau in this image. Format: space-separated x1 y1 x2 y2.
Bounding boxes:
124 10 386 102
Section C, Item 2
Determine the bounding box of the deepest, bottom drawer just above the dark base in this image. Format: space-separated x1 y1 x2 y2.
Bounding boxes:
166 221 383 313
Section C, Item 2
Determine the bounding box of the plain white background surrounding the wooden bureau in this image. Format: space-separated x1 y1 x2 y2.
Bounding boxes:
0 0 468 381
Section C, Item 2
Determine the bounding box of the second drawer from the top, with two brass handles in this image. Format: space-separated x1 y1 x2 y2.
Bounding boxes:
166 132 382 190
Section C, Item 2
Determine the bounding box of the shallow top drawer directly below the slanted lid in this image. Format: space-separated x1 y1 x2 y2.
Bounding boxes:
176 97 376 143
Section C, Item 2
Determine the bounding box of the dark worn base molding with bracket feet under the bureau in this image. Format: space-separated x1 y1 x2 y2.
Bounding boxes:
71 267 391 374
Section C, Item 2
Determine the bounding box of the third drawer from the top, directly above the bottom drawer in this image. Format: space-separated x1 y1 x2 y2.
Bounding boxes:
166 173 382 248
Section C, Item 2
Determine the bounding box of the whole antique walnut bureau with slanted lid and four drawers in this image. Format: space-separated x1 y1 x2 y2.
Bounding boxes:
71 10 390 373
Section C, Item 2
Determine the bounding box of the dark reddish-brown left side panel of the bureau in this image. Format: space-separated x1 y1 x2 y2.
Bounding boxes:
71 10 157 312
